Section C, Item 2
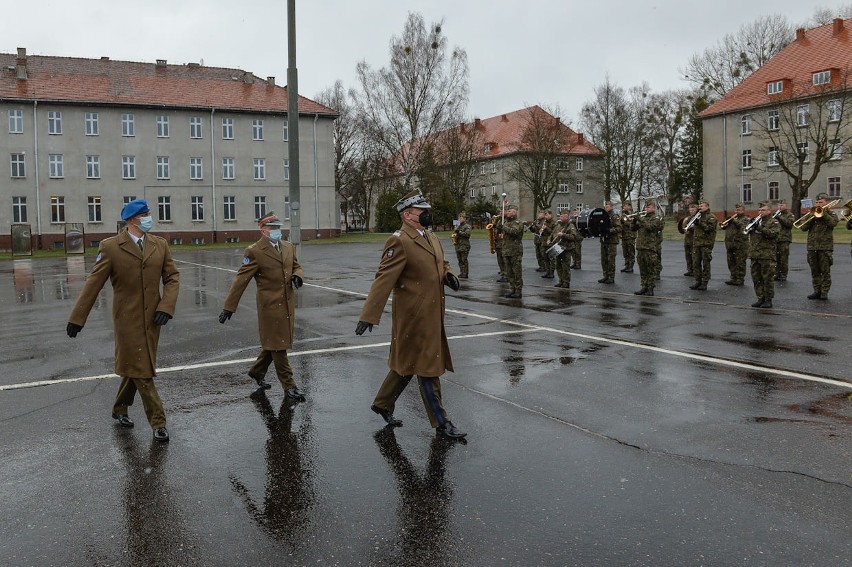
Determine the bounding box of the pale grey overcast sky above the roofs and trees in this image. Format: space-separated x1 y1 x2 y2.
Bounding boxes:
0 0 848 124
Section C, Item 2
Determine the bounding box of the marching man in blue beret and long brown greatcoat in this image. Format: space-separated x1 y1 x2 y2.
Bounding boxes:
66 199 180 442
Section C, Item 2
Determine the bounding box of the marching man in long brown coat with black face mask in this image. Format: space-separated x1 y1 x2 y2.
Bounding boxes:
355 190 466 439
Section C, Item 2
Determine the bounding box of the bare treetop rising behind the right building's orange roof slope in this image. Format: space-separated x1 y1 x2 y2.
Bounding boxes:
681 14 795 97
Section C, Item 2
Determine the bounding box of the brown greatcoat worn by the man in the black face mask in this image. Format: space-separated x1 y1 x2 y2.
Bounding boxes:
360 224 453 377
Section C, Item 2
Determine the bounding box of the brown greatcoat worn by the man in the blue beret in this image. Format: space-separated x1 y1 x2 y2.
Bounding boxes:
68 230 180 378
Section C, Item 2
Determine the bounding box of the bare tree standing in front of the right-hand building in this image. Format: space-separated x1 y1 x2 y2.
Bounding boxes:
743 71 852 215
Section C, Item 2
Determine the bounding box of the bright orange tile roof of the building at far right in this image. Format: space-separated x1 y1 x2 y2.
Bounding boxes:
700 18 852 118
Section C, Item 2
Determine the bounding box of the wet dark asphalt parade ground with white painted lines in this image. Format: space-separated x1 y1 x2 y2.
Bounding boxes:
0 240 852 566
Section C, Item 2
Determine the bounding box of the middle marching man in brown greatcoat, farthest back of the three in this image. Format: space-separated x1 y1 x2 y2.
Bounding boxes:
219 212 305 401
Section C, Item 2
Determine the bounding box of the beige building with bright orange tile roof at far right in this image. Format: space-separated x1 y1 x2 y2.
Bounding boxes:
701 19 852 217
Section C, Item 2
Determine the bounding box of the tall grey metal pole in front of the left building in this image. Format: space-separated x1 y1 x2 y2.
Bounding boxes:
287 0 302 257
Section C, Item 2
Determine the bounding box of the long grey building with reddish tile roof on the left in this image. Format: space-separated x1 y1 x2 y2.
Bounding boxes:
0 49 340 249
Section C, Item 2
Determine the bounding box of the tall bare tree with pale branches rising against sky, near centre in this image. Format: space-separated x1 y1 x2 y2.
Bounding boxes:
356 12 468 188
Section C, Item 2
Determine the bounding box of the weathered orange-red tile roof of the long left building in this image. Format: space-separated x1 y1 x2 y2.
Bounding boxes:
0 53 337 116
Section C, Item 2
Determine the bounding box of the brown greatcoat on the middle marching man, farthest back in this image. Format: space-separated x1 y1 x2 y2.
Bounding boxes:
224 236 304 350
